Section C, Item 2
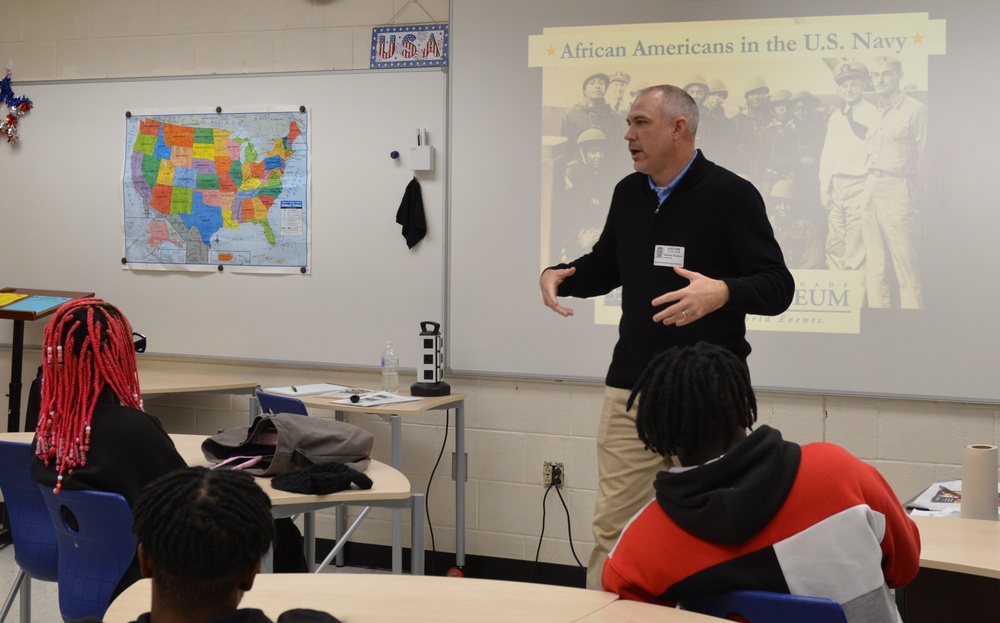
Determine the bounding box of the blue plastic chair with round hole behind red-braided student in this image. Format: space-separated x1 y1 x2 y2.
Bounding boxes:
38 485 136 622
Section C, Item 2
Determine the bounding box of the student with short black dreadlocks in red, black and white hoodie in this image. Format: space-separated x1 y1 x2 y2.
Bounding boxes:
603 342 920 623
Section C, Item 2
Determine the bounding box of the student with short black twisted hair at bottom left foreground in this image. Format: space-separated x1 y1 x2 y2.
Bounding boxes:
79 467 338 623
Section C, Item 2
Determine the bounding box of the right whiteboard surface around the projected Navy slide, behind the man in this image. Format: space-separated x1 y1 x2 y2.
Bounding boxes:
449 0 1000 403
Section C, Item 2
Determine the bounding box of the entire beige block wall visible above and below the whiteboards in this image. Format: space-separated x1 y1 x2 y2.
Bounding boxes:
0 0 1000 564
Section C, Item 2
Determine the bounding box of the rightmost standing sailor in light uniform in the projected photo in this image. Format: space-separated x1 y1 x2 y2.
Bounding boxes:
861 58 927 309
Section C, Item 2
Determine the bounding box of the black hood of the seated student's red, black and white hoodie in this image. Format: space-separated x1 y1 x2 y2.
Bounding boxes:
653 425 802 545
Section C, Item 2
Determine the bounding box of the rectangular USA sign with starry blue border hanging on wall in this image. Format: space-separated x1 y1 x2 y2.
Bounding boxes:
369 24 448 69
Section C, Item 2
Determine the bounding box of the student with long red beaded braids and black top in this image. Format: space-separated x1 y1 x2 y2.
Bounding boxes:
32 298 186 594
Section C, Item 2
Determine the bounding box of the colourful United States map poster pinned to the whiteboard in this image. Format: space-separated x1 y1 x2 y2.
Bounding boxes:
122 109 310 274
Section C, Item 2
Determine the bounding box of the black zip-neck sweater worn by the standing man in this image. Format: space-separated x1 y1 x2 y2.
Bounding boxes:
558 151 795 389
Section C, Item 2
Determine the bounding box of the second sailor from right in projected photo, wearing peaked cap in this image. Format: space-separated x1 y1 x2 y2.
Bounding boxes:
819 60 879 270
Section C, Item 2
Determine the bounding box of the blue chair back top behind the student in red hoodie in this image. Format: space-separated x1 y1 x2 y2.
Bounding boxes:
680 591 847 623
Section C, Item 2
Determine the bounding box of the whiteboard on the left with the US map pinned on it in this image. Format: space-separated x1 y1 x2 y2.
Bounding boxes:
0 70 447 367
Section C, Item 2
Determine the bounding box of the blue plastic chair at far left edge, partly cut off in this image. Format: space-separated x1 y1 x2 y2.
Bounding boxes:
0 441 59 623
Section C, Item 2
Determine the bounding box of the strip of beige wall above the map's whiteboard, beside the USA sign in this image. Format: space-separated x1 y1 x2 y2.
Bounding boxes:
0 0 448 79
